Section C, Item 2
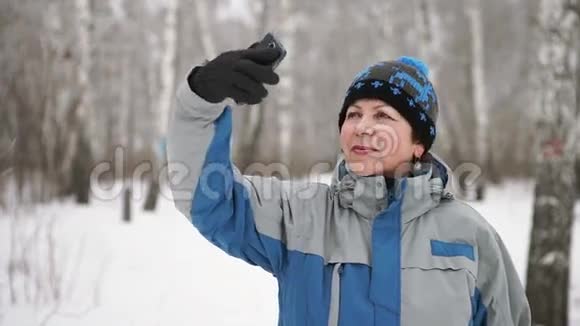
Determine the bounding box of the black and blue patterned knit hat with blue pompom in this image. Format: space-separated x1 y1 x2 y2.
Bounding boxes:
338 57 439 151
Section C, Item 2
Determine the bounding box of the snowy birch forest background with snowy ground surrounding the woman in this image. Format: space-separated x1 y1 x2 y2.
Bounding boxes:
0 0 580 326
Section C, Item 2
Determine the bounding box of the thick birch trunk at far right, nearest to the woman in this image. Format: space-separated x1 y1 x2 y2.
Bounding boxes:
526 0 580 326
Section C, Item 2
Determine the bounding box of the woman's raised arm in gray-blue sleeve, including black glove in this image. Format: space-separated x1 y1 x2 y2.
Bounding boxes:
167 49 292 274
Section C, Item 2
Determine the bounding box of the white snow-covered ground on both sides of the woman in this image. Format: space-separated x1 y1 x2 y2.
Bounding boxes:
0 181 580 326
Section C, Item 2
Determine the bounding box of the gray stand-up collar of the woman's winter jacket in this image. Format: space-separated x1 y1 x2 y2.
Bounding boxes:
331 154 452 223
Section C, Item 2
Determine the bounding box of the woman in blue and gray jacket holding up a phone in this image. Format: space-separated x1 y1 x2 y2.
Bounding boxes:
168 44 530 326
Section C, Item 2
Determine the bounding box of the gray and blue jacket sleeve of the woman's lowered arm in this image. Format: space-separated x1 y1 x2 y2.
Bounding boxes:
472 226 531 326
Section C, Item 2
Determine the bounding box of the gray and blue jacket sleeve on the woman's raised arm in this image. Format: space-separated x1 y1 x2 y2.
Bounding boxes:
167 74 292 274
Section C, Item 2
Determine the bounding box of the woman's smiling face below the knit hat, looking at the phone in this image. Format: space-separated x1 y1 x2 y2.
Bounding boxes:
340 99 425 177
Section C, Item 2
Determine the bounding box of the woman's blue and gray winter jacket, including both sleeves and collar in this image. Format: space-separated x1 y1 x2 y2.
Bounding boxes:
168 74 530 326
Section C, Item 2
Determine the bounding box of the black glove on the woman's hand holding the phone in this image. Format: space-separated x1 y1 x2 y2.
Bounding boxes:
187 47 280 104
